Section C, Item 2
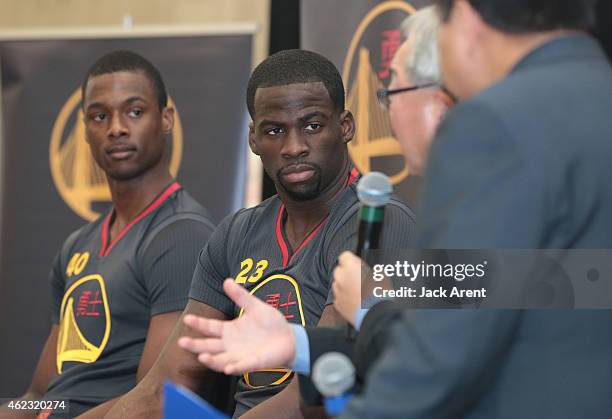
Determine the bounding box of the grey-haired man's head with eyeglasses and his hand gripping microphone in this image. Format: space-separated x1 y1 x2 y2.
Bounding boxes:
333 7 453 336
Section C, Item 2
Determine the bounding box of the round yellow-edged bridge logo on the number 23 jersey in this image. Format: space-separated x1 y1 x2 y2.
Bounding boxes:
238 274 306 388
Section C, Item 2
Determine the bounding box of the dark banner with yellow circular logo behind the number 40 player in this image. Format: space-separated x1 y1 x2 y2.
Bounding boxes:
0 25 254 397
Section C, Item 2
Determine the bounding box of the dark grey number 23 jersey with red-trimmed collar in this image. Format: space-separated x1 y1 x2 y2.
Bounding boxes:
189 169 415 416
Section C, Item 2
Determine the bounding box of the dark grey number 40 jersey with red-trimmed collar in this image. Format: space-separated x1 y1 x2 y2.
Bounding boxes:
45 182 214 417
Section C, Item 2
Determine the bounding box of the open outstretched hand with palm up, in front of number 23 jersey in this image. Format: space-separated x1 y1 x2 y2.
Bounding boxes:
178 278 295 375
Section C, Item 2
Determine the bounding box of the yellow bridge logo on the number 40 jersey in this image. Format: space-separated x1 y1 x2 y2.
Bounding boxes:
57 274 111 374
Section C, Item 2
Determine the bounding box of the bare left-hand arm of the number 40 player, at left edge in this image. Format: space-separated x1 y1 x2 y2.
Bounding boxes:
0 324 59 419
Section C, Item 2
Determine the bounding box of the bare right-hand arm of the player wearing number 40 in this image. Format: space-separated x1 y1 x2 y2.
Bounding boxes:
79 311 182 419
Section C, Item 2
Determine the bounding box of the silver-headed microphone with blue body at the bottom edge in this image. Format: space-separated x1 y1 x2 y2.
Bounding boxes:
312 352 355 417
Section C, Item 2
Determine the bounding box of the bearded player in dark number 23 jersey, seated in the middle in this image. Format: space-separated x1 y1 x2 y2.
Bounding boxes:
110 50 414 418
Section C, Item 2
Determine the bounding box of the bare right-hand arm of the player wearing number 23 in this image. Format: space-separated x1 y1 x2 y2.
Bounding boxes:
241 305 346 419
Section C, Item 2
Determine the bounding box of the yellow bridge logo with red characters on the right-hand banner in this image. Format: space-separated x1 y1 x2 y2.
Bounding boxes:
342 1 415 184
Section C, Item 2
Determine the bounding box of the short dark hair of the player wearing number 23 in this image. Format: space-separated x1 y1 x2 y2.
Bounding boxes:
247 49 344 118
